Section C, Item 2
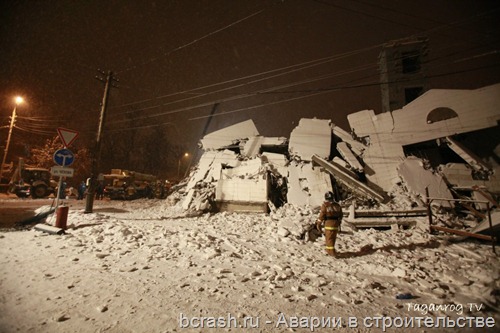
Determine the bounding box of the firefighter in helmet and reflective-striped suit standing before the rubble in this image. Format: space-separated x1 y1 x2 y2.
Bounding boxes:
316 192 342 256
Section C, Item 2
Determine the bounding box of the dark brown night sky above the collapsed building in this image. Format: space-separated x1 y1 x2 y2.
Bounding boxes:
0 0 500 173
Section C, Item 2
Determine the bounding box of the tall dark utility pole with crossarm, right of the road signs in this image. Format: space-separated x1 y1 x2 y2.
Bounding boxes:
84 71 115 213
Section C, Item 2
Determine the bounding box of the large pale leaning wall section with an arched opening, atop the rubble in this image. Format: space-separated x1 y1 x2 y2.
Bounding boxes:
348 84 500 191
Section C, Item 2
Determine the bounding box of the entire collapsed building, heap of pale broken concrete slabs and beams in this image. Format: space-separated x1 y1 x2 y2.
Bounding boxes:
178 84 500 236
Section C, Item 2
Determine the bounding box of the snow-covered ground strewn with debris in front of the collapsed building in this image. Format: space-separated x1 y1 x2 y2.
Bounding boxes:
0 200 500 333
